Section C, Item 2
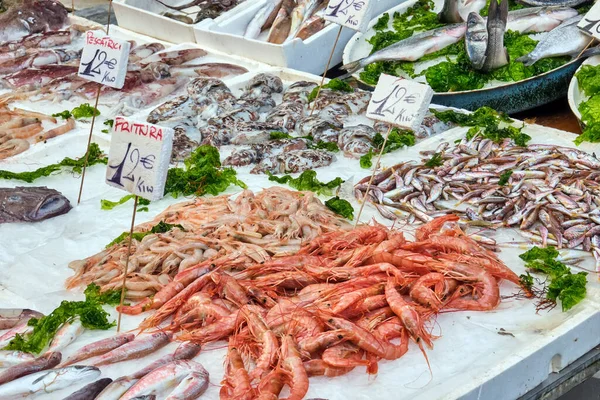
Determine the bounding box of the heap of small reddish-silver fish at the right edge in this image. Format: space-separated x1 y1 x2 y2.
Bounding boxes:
355 130 600 263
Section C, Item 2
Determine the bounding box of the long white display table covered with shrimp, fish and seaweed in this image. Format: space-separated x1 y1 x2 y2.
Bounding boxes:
0 0 600 400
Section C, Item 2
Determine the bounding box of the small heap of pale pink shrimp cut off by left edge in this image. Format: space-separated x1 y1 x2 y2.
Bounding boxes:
0 107 75 160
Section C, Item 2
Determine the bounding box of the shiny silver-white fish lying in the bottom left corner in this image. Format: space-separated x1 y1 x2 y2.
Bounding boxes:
0 365 100 399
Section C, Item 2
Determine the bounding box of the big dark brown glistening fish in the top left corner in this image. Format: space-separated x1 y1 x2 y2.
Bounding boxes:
0 0 68 43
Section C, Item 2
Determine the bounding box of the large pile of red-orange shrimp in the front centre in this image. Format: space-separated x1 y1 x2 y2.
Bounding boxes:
122 215 520 399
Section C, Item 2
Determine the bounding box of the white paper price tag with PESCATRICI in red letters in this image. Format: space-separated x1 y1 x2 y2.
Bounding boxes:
77 31 131 89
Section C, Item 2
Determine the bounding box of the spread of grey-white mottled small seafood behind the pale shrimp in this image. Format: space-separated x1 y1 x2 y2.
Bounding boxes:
148 73 449 174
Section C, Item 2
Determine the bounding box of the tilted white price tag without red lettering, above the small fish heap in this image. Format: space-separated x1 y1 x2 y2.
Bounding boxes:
366 74 433 131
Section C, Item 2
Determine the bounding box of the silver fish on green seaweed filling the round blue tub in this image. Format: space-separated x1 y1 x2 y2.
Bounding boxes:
350 0 589 92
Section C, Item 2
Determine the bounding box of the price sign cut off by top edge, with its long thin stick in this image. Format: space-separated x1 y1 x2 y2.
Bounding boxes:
310 0 375 115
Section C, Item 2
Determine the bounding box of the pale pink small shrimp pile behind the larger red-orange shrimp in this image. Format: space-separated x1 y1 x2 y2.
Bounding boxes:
66 187 352 300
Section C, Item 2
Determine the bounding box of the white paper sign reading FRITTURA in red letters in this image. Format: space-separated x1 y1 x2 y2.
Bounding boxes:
106 117 174 201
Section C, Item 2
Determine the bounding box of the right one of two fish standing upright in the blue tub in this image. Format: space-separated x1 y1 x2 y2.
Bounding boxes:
481 0 508 71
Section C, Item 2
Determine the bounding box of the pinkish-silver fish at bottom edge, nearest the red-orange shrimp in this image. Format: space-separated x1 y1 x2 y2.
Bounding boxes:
120 360 208 400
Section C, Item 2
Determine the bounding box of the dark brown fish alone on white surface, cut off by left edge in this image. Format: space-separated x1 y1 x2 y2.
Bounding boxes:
0 187 71 224
